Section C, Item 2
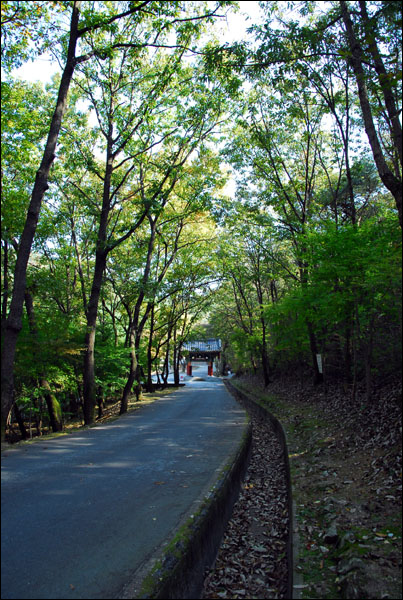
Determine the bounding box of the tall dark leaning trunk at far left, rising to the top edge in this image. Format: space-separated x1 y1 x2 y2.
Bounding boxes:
1 2 80 439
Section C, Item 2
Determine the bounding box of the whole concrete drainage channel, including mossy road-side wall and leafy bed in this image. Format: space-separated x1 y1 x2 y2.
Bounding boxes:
131 381 293 599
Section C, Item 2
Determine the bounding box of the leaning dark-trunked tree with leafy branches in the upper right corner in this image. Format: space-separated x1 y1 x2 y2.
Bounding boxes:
251 0 402 224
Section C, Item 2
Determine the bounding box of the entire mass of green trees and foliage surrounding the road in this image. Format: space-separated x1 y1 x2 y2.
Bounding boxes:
1 1 402 440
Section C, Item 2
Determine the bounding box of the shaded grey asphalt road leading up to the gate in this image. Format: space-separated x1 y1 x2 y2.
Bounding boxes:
1 377 245 599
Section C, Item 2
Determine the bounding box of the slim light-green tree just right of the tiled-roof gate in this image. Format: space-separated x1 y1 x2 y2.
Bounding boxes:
210 198 278 386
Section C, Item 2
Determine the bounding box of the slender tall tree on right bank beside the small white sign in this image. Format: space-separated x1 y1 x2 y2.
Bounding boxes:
228 78 332 383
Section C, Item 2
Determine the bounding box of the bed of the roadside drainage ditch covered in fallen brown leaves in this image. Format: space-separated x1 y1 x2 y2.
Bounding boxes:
202 381 299 599
